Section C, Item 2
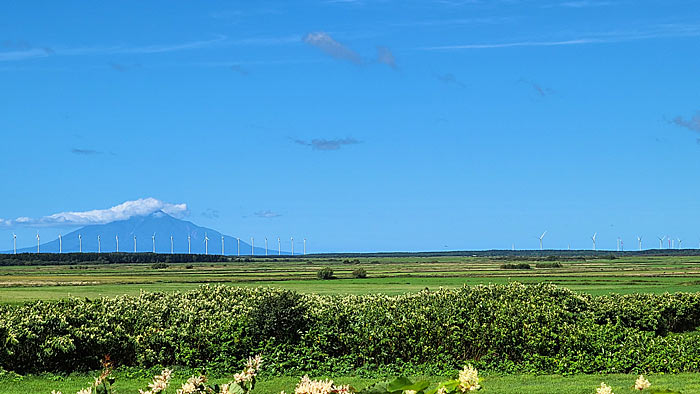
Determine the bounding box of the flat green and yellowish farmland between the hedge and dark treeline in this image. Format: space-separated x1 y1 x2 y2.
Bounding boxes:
0 256 700 304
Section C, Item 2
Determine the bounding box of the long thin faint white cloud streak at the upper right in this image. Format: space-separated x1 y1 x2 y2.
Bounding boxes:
417 24 700 51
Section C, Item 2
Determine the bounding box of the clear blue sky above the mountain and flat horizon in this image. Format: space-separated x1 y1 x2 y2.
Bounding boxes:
0 0 700 252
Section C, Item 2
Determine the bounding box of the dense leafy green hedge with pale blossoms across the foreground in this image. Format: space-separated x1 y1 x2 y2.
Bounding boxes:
0 283 700 375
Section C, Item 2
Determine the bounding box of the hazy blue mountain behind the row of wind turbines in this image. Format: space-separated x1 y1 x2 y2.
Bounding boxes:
5 211 289 256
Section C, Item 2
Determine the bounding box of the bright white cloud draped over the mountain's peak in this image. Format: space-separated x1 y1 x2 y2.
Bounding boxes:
0 197 189 227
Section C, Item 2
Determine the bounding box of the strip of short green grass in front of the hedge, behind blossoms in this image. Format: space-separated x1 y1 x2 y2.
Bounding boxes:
0 373 700 394
